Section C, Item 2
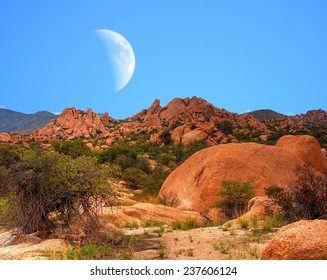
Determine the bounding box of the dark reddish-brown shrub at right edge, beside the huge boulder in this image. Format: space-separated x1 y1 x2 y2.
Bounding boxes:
266 165 327 220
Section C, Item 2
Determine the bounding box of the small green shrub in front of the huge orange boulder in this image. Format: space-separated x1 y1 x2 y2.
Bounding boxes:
213 180 255 219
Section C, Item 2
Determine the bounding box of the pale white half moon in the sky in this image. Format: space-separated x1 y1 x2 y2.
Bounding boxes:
96 29 135 92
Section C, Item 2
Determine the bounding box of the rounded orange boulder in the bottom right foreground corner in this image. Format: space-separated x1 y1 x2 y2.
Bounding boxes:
261 220 327 260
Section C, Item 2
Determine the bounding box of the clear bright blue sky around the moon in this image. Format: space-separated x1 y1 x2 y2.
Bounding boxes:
0 0 327 118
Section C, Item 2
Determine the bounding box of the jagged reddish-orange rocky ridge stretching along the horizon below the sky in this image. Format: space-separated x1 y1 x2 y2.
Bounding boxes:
0 97 327 146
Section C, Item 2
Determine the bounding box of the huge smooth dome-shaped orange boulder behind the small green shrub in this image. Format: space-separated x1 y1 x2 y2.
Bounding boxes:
159 143 303 213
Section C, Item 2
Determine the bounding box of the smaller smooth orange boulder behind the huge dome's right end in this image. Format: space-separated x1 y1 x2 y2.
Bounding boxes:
276 135 327 173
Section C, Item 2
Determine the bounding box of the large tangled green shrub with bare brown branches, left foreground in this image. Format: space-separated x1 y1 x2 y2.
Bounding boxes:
0 150 114 233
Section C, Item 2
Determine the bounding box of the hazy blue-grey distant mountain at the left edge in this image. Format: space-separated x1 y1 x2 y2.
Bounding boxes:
0 109 57 133
